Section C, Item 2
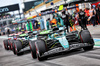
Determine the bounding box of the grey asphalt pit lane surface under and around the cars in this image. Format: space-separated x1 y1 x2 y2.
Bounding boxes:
0 25 100 66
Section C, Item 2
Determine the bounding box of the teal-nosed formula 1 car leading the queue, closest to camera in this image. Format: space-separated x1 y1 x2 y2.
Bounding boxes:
29 28 94 61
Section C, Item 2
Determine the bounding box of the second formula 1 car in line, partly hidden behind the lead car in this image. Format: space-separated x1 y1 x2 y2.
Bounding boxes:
13 31 37 55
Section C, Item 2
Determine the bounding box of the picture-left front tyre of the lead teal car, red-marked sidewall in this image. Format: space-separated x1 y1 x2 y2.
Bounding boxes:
35 40 47 61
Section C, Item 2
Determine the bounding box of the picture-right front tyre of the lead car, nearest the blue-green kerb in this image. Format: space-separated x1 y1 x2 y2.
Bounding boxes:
80 30 94 51
